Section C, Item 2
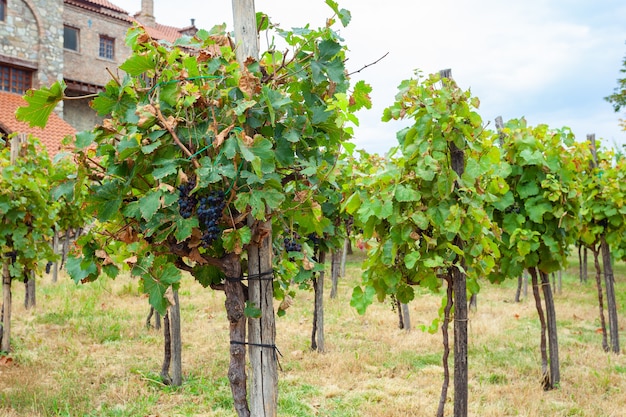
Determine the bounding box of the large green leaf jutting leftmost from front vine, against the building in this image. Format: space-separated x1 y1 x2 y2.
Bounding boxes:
15 81 65 128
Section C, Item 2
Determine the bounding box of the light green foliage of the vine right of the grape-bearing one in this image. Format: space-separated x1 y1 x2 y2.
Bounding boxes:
343 72 503 312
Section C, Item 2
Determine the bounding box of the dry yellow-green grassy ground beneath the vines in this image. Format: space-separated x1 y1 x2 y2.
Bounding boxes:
0 254 626 417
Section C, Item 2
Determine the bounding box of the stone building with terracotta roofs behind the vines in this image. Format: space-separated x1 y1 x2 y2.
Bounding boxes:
0 0 196 155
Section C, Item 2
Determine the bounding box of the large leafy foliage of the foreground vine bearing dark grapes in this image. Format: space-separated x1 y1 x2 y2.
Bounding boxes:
17 13 370 311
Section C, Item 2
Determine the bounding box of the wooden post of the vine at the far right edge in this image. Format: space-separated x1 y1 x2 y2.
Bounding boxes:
587 134 620 354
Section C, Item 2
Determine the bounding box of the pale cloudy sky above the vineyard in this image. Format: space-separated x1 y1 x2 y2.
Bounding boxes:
111 0 626 155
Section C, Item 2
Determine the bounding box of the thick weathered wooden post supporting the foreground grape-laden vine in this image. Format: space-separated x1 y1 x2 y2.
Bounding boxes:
232 0 278 417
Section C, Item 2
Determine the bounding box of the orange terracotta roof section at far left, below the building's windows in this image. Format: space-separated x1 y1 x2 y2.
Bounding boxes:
0 91 76 158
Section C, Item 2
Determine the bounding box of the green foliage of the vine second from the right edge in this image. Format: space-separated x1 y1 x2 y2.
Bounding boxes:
490 119 584 281
